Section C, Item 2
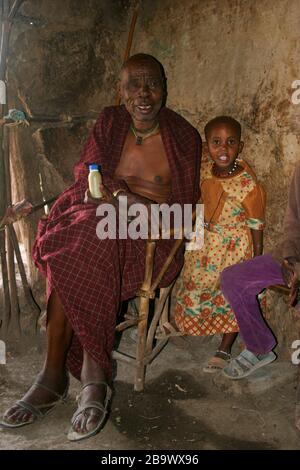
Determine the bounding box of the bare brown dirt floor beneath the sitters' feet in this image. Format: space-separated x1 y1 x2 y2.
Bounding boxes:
0 331 300 450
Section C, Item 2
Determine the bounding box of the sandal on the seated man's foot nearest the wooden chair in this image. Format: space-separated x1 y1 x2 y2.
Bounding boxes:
68 382 112 442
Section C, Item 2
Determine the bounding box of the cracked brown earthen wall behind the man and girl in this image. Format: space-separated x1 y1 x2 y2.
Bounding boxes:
8 0 300 350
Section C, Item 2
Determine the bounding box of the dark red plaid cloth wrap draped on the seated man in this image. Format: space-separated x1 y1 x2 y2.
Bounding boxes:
33 106 201 378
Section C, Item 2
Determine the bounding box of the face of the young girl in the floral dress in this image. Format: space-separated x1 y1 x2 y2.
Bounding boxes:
207 123 244 172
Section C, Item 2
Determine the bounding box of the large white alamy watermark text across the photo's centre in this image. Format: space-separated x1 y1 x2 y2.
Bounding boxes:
96 196 204 250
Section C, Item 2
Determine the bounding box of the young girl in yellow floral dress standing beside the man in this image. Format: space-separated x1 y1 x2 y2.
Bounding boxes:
175 116 265 372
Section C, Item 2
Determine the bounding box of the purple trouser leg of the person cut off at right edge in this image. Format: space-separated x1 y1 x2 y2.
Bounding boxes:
221 255 285 354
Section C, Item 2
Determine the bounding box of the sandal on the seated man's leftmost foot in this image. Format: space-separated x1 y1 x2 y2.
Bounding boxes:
0 376 70 429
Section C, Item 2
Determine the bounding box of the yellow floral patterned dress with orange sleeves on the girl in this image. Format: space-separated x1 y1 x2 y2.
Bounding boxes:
175 160 265 336
